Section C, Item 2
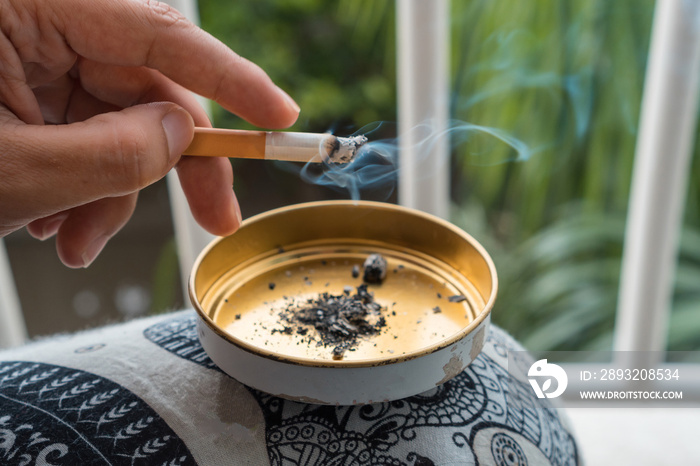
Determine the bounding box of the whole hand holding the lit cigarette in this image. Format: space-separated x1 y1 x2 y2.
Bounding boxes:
0 0 299 267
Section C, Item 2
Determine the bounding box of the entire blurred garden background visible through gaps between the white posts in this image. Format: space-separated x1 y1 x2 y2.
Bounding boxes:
6 0 700 350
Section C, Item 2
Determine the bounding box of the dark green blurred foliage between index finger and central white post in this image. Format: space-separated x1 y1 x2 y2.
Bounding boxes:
199 0 396 132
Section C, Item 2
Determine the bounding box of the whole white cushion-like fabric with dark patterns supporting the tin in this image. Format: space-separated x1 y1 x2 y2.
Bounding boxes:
0 311 579 466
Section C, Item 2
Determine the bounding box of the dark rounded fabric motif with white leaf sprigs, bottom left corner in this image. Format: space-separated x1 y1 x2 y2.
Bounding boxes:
0 361 196 466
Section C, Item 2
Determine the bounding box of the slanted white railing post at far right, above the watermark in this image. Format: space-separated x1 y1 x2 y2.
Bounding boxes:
614 0 700 364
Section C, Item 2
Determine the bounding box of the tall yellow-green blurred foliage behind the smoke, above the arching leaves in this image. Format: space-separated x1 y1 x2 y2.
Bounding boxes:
453 0 653 241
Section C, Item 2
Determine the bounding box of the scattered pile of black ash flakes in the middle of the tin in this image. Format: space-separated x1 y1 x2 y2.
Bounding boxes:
273 284 387 360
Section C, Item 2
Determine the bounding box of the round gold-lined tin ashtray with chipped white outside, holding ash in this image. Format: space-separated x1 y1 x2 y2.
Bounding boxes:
189 201 498 405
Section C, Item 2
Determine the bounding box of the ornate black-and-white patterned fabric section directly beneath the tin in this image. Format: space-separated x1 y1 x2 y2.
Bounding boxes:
144 315 579 466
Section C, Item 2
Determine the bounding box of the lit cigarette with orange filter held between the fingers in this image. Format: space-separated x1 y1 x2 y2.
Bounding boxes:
183 128 367 163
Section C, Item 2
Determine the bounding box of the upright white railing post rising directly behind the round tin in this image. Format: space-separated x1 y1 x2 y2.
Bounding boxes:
396 0 450 218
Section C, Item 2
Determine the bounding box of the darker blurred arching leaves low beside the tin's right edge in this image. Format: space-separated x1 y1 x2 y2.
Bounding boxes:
453 204 700 351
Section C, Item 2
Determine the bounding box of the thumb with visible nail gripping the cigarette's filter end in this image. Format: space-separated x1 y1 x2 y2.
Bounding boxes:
0 103 194 223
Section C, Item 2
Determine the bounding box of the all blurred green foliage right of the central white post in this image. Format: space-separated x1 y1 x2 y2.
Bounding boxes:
453 0 700 350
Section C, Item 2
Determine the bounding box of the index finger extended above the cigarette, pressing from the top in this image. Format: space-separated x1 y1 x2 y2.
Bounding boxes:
56 0 299 128
